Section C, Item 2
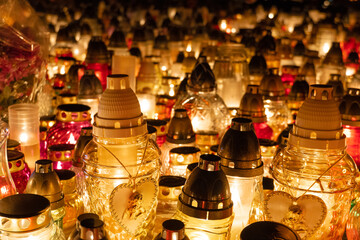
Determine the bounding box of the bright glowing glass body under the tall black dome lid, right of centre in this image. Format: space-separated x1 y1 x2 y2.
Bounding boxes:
226 175 264 240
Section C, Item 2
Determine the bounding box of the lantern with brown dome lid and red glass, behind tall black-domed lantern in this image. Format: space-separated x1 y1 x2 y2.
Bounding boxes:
238 85 273 139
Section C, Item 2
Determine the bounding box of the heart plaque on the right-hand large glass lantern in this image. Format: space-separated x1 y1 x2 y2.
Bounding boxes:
265 191 327 239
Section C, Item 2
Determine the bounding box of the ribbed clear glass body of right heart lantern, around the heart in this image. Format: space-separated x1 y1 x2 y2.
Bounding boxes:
272 145 356 240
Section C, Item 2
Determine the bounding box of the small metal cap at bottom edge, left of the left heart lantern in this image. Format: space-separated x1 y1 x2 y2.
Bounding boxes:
80 218 106 240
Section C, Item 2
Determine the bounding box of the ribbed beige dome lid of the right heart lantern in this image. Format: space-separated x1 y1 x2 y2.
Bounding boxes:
289 85 345 149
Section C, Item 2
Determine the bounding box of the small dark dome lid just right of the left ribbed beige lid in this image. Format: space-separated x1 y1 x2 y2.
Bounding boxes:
166 109 195 144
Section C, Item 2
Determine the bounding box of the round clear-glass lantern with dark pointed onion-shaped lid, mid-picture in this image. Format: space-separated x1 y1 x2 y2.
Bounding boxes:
174 56 230 152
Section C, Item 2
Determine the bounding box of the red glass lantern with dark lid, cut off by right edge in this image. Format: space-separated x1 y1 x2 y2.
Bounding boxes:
339 88 360 168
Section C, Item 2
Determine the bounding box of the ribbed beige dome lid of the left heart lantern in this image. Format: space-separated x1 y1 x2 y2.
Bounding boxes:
93 74 147 138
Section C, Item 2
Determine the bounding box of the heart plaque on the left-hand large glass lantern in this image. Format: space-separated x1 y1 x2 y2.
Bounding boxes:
110 178 158 236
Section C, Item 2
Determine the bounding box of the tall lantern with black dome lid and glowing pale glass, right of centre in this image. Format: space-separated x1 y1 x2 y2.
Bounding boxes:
218 118 264 239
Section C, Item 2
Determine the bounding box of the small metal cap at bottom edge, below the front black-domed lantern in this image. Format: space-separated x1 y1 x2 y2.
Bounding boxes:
161 219 185 240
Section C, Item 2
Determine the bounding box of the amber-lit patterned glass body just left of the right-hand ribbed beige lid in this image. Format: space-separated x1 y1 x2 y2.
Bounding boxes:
264 99 291 140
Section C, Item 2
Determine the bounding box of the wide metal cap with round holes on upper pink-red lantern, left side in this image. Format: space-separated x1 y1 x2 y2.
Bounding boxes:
56 104 91 122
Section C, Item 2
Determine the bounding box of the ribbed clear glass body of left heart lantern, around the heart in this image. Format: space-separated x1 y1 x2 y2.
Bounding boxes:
79 134 160 240
